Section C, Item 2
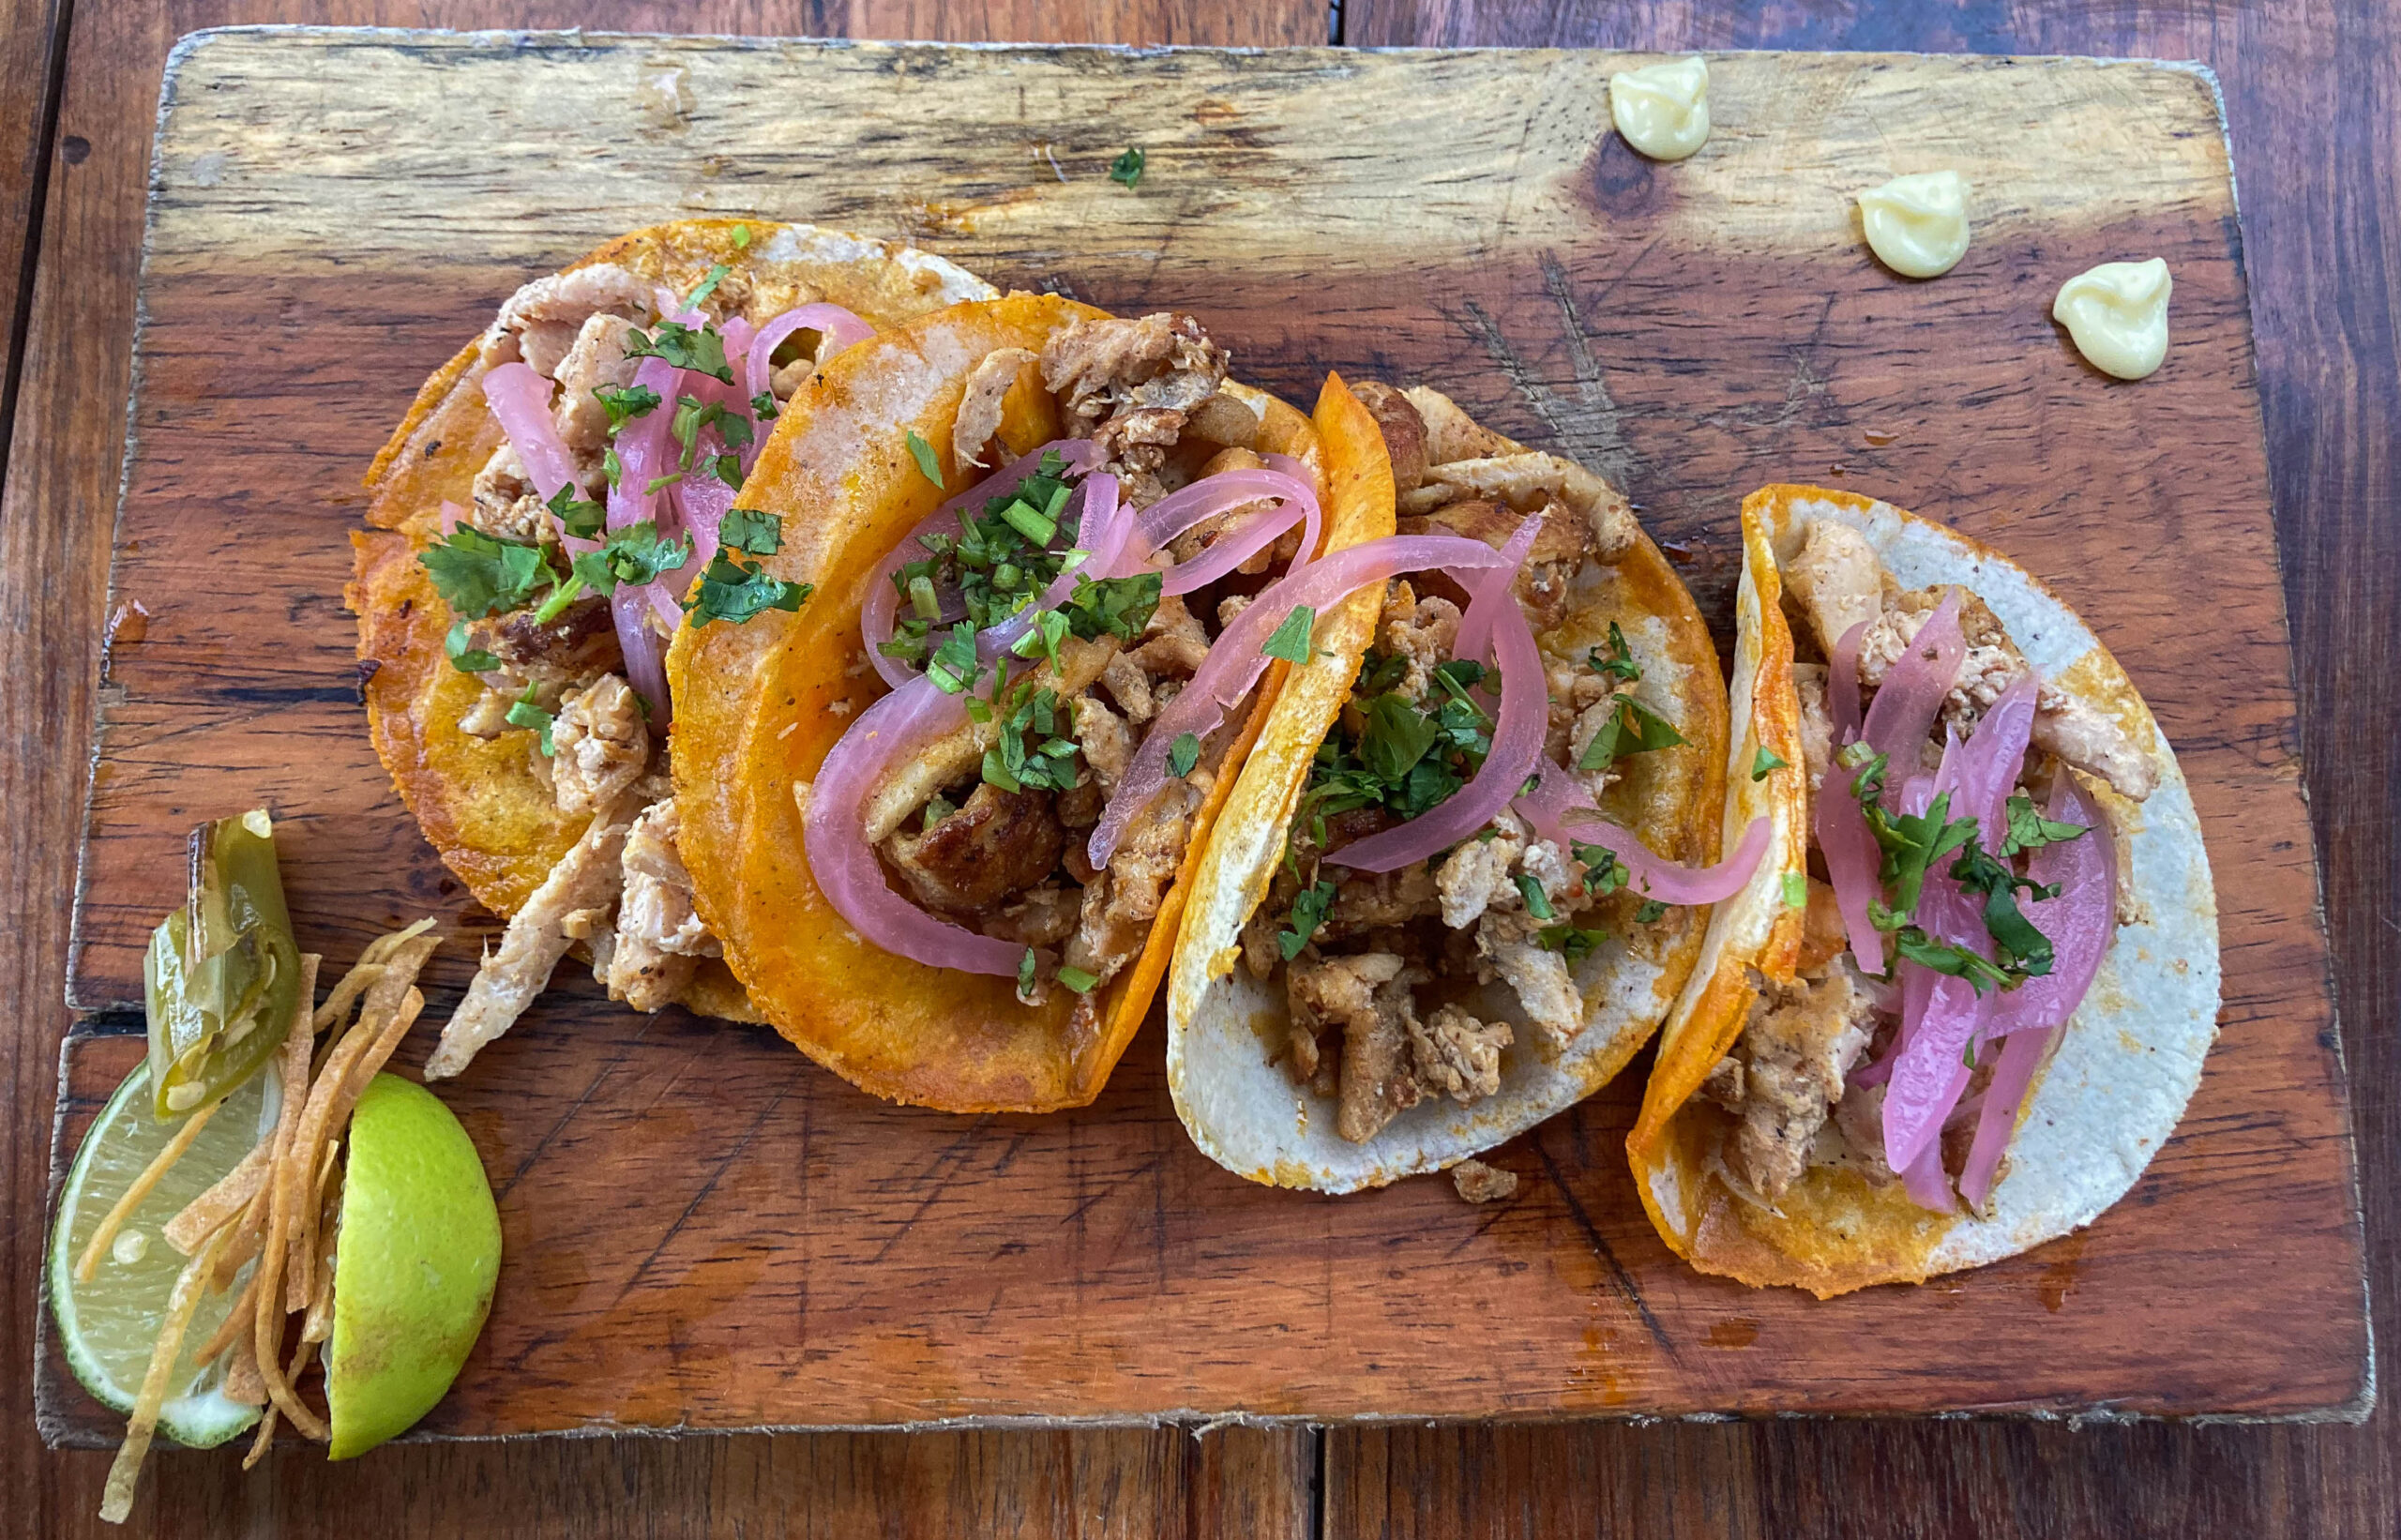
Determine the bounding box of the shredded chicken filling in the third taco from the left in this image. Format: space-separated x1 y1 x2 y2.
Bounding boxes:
1242 382 1638 1141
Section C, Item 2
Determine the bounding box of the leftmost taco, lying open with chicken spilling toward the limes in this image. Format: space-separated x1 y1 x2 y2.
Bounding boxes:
346 221 991 1077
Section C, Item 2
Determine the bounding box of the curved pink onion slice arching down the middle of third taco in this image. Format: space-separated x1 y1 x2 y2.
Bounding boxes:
1325 514 1551 872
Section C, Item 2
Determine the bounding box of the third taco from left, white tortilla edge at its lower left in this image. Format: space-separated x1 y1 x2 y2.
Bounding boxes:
1167 385 1765 1192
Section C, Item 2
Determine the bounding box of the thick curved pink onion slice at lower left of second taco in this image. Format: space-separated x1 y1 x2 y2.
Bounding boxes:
802 680 1025 975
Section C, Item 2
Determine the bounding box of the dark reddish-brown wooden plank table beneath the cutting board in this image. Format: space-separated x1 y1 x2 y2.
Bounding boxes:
0 0 2401 1535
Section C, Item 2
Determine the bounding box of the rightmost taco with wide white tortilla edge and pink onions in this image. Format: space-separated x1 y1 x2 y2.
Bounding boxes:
1628 485 2218 1297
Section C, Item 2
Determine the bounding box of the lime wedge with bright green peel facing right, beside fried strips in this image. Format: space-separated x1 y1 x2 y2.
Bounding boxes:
325 1074 499 1460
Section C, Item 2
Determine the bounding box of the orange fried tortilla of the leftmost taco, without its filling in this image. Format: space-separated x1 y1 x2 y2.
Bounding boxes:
343 219 991 1019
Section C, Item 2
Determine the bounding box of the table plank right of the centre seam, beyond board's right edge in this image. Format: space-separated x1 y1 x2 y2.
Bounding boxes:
1325 0 2401 1537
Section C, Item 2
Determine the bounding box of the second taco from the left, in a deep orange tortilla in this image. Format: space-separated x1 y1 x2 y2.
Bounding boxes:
668 294 1376 1112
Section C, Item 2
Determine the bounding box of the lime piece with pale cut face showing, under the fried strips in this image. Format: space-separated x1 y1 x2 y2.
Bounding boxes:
51 1064 281 1449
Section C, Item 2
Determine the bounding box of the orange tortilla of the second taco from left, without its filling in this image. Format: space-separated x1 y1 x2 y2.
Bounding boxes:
668 294 1373 1112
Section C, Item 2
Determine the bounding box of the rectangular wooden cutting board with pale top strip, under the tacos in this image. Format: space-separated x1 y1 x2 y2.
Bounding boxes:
38 31 2372 1439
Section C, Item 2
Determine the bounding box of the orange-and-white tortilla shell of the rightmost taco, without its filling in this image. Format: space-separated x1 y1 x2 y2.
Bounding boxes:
1628 485 2218 1297
